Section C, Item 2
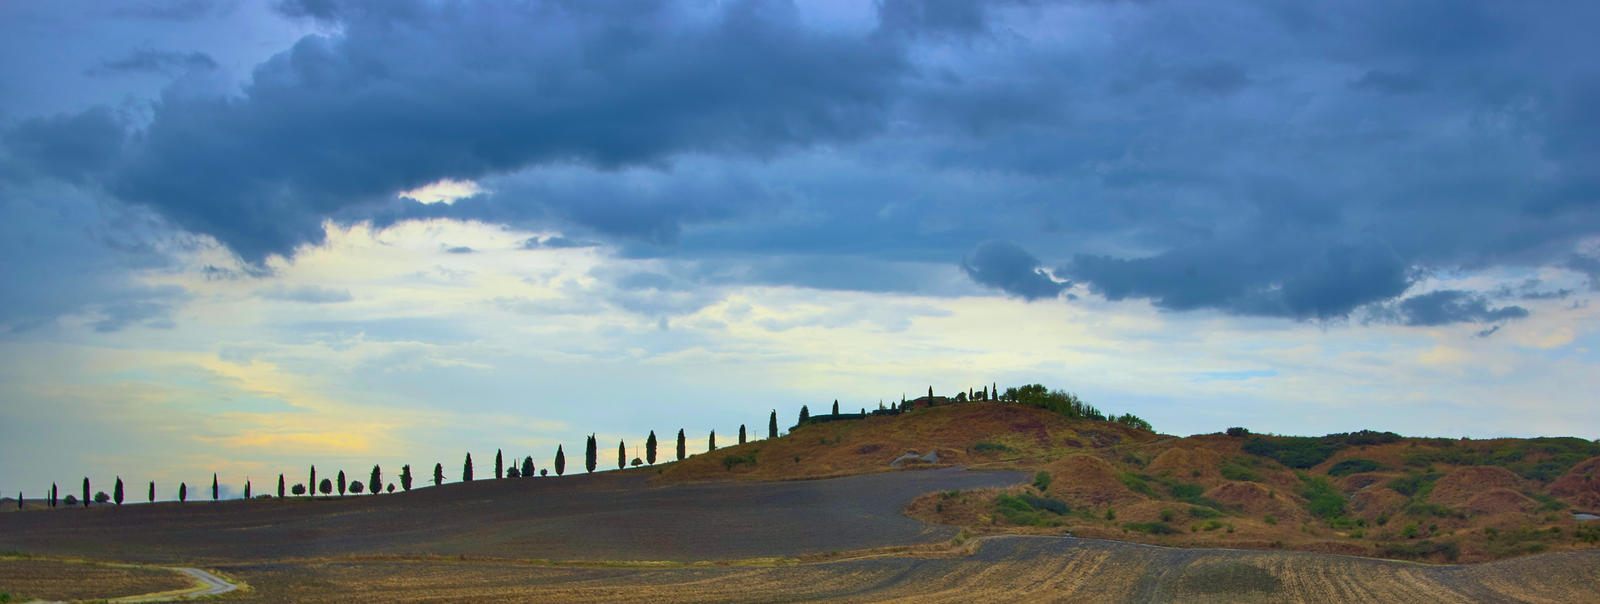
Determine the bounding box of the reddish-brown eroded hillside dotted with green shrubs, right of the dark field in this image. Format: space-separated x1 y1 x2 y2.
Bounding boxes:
656 403 1600 561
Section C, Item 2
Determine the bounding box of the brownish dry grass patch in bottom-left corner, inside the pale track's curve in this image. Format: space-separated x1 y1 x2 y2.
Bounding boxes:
0 556 195 601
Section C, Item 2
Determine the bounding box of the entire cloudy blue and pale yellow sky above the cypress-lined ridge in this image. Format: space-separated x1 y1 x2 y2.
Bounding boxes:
0 0 1600 497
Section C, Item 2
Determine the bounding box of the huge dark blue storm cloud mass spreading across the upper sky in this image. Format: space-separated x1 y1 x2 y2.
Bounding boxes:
3 0 1600 323
